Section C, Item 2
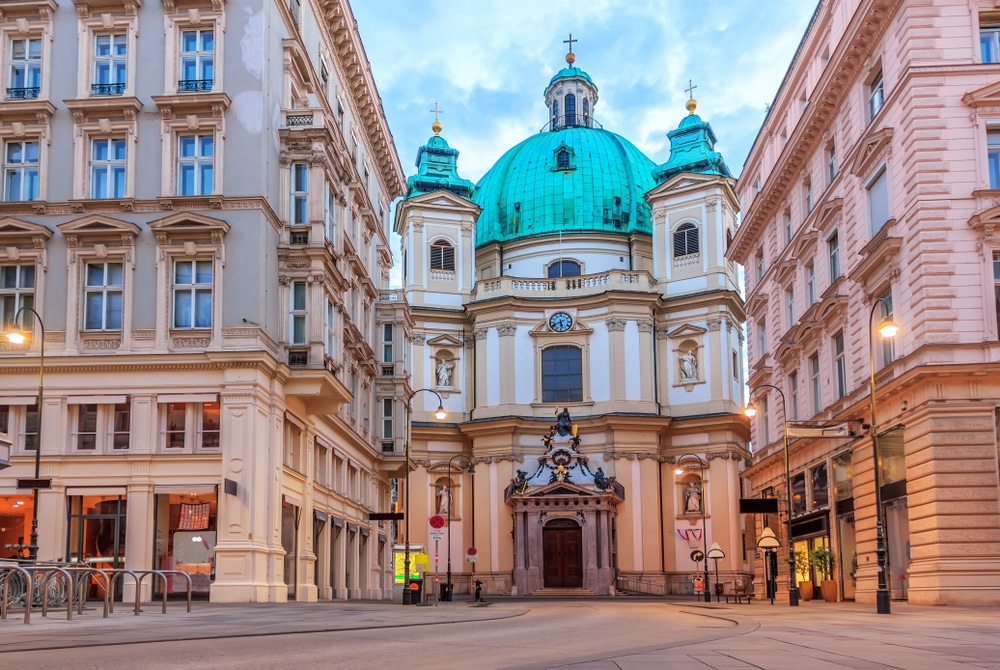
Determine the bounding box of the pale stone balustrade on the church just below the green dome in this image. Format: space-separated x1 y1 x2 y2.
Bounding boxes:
473 270 655 300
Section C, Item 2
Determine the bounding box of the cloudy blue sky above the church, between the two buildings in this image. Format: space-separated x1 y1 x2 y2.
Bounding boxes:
352 0 816 181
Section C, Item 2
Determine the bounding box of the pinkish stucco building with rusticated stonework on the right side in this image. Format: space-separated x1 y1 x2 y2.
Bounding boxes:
727 0 1000 604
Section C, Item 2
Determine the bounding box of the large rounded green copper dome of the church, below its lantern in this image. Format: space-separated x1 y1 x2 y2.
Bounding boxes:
473 127 656 247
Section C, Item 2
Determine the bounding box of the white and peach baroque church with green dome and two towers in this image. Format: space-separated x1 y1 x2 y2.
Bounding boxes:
388 52 752 595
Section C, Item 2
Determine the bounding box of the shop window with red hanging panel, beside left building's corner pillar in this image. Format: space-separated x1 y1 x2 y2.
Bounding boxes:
152 485 218 597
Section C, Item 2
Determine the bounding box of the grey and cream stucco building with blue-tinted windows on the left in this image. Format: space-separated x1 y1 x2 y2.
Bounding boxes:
0 0 405 602
